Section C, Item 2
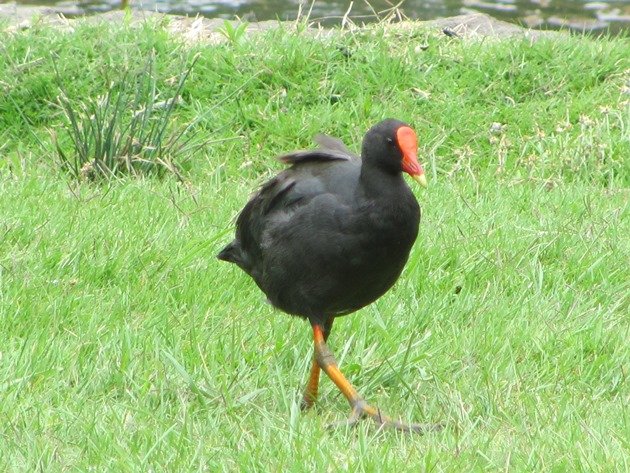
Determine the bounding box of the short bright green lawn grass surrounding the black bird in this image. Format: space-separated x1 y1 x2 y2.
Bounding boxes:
0 17 630 472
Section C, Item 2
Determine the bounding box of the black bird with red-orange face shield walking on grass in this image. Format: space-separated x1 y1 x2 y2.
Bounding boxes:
217 118 427 432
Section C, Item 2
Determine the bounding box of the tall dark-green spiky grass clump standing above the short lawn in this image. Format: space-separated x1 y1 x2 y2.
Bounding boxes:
53 51 196 180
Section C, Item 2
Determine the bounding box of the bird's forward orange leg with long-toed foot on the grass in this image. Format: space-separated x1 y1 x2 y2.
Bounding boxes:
309 324 441 433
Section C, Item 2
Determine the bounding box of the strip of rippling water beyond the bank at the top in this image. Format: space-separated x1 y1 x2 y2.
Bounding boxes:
0 0 630 33
